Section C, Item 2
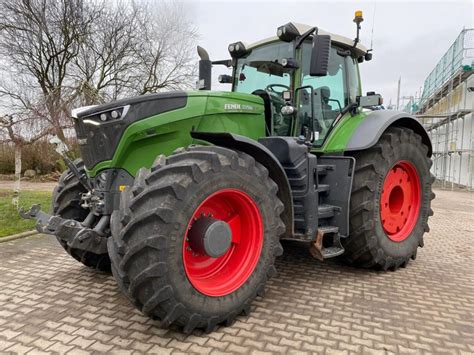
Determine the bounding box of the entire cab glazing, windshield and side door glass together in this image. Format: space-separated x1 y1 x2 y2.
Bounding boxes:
233 40 360 143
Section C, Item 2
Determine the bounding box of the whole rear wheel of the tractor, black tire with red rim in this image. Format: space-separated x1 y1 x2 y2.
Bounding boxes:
343 127 434 270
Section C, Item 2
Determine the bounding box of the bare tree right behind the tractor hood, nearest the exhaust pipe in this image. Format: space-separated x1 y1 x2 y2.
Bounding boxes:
75 1 198 104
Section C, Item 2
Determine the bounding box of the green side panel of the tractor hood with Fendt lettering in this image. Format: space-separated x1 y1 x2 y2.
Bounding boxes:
87 91 265 177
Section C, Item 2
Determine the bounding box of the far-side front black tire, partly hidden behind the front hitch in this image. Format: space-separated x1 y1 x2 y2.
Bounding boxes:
51 159 110 272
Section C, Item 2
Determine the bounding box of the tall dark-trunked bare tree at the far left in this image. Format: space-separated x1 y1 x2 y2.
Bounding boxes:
0 0 94 139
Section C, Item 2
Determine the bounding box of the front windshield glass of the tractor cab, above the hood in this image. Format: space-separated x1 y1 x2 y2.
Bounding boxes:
233 42 293 94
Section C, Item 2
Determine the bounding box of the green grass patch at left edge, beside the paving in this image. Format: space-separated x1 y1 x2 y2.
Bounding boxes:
0 189 51 238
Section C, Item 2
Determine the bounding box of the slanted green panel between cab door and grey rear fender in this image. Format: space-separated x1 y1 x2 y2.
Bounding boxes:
312 112 368 153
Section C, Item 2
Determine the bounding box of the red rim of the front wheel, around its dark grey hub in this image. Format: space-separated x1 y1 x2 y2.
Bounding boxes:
183 189 263 297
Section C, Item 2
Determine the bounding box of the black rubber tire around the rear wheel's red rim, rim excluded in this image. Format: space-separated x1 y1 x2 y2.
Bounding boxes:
343 127 435 270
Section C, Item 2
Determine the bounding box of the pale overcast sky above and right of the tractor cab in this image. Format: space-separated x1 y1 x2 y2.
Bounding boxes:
186 0 474 104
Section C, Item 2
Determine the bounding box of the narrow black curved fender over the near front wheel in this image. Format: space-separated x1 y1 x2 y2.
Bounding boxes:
191 131 293 237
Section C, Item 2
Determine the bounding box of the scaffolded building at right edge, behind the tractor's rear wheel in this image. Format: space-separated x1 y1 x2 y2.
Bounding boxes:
414 29 474 191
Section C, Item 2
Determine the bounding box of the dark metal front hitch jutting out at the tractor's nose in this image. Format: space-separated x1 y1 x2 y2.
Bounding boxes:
18 205 110 254
